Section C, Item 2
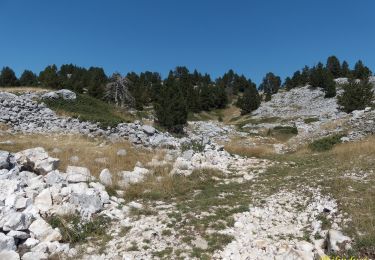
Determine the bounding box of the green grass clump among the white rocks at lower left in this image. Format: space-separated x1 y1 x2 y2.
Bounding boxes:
47 215 109 244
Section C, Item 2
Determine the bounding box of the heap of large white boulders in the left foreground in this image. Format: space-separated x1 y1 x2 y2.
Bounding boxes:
0 147 118 259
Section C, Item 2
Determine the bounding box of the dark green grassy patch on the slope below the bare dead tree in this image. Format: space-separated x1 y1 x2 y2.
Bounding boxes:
44 94 134 128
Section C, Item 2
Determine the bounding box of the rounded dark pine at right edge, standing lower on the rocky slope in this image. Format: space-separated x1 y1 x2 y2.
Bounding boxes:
338 79 374 113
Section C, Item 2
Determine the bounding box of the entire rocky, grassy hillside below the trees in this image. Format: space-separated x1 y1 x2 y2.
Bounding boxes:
0 84 375 259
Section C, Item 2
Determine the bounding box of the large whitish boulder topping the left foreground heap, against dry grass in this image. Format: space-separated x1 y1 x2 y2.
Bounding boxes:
14 147 60 175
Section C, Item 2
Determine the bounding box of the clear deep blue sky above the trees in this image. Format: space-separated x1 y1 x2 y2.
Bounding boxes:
0 0 375 83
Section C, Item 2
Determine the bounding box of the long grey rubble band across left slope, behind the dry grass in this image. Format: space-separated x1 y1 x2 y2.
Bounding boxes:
0 91 180 148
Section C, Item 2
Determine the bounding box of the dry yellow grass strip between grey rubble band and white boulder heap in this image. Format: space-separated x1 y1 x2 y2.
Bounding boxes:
0 134 154 180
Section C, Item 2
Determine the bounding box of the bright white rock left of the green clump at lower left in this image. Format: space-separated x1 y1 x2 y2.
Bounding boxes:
29 218 61 242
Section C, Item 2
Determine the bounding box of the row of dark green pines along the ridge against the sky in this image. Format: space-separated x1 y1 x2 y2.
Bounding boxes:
0 56 372 132
